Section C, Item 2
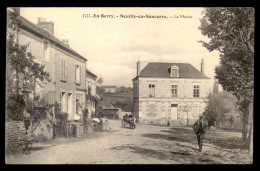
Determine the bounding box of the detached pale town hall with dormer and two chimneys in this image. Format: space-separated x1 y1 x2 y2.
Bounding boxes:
132 60 210 125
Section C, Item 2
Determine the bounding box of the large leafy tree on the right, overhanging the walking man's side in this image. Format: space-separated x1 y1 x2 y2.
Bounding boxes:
199 7 255 155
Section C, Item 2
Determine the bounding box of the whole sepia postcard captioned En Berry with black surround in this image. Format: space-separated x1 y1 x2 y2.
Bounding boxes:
5 7 255 164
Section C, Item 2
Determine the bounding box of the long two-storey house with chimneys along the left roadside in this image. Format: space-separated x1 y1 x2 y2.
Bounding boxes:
19 17 87 121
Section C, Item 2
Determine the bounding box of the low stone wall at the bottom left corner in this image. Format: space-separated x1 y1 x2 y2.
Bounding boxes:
5 121 26 154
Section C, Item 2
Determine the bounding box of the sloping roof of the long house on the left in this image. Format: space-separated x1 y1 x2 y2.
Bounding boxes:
19 16 87 60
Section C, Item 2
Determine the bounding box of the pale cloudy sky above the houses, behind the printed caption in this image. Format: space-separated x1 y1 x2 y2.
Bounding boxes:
20 7 219 90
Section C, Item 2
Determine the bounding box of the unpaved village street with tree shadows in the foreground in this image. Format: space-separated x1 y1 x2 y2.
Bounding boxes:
6 120 251 164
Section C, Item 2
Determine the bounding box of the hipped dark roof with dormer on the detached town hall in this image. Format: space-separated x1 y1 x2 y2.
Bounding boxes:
139 62 210 79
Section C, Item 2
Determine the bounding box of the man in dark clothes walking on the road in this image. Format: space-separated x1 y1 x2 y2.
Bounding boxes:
193 115 207 152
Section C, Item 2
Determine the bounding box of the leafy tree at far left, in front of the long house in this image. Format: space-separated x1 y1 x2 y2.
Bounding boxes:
6 8 51 120
